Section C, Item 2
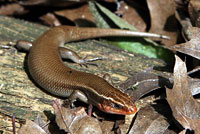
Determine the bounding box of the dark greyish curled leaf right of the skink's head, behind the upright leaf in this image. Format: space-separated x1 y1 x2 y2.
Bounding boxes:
119 72 200 102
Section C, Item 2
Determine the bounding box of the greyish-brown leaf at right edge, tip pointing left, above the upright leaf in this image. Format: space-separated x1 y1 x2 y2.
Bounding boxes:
173 27 200 59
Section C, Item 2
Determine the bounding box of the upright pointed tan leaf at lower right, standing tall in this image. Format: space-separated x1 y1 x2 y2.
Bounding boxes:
166 56 200 134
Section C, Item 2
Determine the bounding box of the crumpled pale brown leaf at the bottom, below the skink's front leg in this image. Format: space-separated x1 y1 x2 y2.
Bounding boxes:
53 100 102 134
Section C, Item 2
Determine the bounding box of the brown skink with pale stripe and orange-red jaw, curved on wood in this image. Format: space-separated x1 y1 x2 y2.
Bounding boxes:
16 26 168 115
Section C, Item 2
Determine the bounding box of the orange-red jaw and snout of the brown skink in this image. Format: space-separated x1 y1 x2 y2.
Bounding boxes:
98 104 137 115
